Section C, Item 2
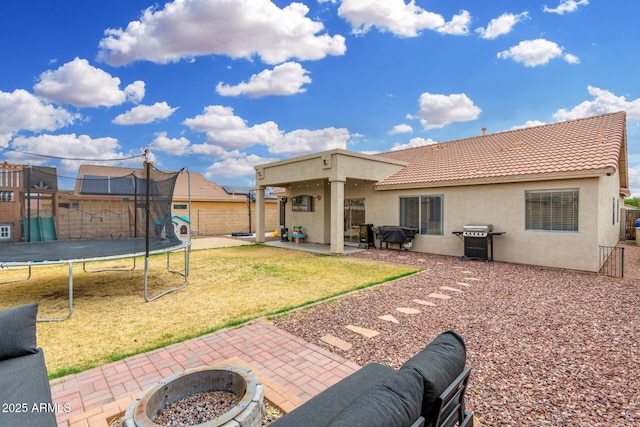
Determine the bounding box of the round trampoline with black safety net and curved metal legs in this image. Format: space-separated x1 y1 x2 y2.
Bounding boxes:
0 162 191 322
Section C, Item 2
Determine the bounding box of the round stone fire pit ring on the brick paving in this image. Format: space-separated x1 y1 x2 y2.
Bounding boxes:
124 365 264 427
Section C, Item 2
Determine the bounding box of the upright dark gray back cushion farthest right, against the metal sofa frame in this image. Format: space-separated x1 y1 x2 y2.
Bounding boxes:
400 331 467 425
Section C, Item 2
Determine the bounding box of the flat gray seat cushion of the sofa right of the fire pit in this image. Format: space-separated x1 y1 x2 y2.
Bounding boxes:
271 363 396 427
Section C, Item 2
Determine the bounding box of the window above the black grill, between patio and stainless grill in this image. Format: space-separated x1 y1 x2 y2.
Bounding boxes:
400 195 444 236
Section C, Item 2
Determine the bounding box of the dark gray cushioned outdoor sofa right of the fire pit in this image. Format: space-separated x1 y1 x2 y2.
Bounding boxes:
271 331 473 427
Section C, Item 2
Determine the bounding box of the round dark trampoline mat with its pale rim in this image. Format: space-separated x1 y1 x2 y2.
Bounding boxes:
0 238 188 266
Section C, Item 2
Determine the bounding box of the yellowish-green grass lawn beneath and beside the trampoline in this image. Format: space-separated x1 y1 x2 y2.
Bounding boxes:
0 245 417 378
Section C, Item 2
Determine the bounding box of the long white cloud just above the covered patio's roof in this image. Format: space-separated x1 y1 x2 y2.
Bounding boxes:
183 105 350 157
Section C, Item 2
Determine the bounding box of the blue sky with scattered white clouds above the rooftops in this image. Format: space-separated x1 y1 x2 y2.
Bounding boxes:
0 0 640 192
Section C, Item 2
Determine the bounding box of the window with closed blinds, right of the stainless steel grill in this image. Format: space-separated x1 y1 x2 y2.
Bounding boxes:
525 189 579 231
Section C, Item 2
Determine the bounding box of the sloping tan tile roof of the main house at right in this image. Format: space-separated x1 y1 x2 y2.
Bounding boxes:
376 112 626 189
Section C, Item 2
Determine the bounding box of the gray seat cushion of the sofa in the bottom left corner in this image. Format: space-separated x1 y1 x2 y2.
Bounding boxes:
0 349 56 427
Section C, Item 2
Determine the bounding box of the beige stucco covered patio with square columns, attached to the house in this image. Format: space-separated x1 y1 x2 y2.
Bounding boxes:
255 149 407 254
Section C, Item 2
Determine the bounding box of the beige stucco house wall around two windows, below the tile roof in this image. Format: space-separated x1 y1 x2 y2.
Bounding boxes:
366 177 618 271
